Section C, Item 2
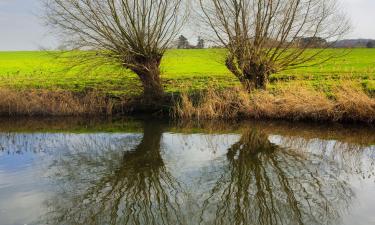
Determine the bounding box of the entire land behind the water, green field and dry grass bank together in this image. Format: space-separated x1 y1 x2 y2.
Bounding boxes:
0 49 375 124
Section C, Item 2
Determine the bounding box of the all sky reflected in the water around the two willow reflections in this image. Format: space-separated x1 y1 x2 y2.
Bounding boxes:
0 130 375 225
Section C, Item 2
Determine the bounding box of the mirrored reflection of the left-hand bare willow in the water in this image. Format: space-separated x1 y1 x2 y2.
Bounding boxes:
47 123 182 224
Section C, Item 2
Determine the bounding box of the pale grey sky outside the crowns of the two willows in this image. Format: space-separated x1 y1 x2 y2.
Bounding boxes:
0 0 375 51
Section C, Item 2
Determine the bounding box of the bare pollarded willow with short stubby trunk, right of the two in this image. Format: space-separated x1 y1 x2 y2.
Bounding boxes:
198 0 350 91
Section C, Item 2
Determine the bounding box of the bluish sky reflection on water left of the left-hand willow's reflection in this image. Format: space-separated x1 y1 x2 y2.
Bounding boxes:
0 133 140 225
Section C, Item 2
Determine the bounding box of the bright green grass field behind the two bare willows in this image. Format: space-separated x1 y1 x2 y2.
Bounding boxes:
0 49 375 95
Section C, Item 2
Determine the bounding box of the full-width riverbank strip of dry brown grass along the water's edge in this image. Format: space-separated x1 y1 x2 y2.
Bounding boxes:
0 82 375 124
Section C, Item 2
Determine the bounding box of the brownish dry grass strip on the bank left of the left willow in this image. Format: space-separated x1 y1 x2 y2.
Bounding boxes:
0 88 114 116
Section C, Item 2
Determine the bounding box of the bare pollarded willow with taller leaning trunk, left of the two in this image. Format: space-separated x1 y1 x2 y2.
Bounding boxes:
45 0 186 96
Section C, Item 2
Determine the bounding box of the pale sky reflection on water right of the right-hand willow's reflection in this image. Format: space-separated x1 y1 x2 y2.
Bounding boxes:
269 135 375 225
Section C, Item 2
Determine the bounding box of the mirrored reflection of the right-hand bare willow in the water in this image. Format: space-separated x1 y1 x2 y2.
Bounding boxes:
201 128 353 225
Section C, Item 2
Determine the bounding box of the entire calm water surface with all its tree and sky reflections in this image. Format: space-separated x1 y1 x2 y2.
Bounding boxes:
0 119 375 225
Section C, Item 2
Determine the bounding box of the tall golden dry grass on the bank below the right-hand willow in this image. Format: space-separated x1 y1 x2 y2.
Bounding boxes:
172 85 375 123
